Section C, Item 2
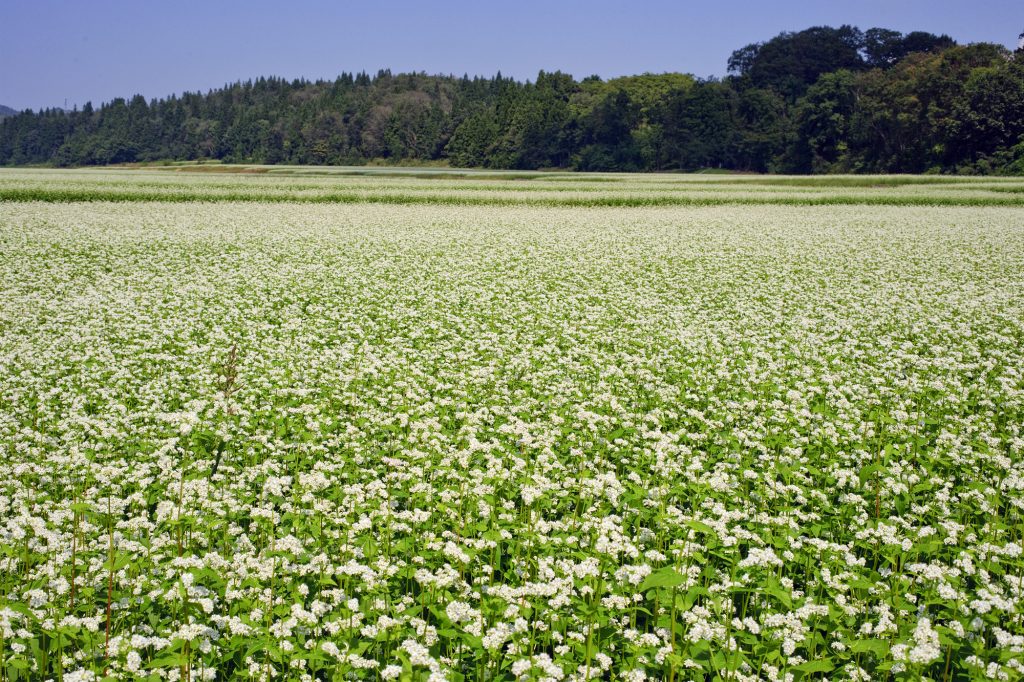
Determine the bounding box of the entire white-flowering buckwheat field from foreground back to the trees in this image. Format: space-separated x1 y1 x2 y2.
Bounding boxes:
0 168 1024 682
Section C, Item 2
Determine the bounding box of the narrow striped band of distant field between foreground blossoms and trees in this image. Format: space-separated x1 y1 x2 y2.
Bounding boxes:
6 165 1024 208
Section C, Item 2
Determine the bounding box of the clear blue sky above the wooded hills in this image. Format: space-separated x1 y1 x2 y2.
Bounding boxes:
0 0 1024 109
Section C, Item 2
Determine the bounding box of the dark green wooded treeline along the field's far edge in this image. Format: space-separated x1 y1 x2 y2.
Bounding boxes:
6 26 1024 173
